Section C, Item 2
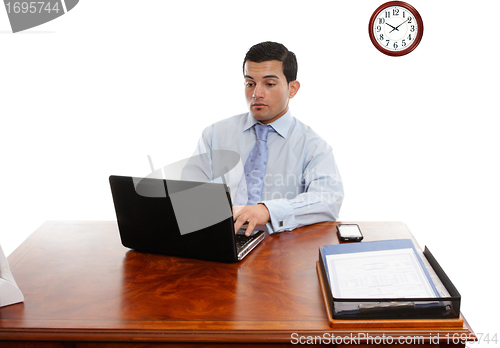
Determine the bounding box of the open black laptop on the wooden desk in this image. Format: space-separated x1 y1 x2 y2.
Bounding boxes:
109 175 265 262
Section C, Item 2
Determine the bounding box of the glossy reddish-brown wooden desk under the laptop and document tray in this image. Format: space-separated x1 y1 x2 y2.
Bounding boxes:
0 222 474 348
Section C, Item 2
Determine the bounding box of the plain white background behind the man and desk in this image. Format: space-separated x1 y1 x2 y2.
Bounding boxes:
0 0 500 344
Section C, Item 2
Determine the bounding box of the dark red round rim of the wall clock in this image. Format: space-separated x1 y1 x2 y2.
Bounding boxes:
368 1 424 57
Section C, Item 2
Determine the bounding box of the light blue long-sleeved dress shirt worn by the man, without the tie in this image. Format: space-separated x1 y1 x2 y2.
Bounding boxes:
186 111 344 233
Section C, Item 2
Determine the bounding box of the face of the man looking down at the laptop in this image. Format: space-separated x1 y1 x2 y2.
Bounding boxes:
244 60 300 124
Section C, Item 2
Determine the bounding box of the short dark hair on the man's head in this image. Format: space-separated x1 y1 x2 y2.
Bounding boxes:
243 41 298 83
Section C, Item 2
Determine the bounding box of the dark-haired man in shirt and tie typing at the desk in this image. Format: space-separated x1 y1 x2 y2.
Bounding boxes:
186 42 344 235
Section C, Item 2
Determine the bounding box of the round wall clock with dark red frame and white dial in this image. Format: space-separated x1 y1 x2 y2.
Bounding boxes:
368 1 424 57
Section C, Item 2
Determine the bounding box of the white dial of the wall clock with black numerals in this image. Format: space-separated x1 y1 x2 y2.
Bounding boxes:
373 6 419 51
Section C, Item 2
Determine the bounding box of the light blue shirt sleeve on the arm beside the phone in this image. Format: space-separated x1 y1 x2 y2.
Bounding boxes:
260 146 344 233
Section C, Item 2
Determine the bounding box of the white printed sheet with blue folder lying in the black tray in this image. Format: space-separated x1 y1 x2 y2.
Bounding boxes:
320 239 439 299
